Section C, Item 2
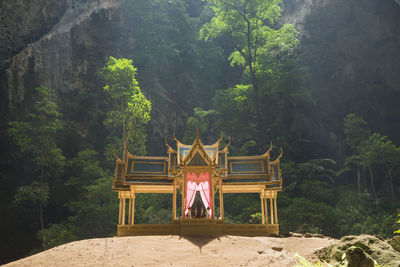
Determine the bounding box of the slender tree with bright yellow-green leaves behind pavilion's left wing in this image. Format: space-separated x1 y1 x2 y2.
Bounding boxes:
102 57 151 160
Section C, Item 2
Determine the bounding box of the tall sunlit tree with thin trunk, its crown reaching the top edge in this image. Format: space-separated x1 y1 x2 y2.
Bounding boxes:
200 0 298 131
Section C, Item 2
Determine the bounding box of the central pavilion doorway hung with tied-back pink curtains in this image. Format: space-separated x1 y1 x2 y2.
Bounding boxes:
184 171 214 218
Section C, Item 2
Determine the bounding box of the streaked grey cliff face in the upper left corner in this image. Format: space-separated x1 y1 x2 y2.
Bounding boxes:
2 0 120 117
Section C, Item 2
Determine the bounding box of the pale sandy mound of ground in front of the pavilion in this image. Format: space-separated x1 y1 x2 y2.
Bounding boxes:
5 236 336 267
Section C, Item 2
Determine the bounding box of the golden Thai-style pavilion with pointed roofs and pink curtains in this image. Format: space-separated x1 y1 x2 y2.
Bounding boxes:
112 134 282 236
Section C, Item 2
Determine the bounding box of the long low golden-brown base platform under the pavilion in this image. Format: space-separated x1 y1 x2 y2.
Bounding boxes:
118 219 279 236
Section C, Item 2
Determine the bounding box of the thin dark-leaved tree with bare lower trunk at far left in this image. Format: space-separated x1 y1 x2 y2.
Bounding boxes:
8 86 65 229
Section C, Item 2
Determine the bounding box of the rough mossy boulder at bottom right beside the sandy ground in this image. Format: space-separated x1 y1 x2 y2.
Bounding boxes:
316 235 400 266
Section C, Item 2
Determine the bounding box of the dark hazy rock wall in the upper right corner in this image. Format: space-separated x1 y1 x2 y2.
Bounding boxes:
282 0 400 155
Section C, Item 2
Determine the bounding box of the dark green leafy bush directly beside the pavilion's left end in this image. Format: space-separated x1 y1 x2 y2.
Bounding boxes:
67 150 118 239
